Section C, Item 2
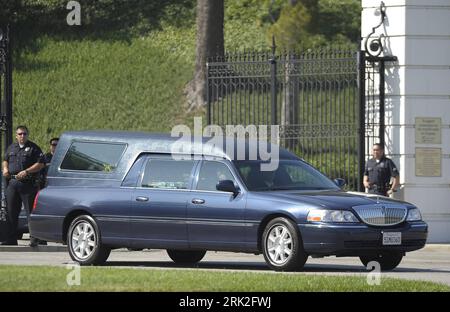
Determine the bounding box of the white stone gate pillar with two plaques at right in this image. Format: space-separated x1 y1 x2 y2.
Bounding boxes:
361 0 450 243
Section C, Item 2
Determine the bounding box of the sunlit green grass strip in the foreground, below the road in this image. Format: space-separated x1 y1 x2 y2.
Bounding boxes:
0 265 450 292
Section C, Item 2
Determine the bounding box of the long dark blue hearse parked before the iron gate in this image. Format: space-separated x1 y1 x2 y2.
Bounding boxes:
29 131 428 270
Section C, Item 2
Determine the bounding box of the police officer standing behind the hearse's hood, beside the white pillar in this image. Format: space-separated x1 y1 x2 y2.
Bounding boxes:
364 143 400 196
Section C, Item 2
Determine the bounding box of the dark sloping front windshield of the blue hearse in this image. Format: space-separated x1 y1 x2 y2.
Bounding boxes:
234 160 339 191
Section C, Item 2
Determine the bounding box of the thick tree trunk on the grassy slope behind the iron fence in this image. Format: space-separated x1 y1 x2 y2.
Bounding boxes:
186 0 224 110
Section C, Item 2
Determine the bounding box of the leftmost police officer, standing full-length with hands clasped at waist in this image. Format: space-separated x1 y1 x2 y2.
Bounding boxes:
2 126 44 246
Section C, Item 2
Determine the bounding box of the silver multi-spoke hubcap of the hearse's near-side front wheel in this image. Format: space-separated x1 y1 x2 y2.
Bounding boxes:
267 225 294 264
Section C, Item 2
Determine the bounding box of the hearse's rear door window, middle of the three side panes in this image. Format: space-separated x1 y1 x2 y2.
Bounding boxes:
141 159 194 190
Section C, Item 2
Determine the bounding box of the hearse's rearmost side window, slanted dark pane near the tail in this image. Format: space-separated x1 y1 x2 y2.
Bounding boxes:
61 142 126 173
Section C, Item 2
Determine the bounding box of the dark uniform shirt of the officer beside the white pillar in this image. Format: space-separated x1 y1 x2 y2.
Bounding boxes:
364 157 398 187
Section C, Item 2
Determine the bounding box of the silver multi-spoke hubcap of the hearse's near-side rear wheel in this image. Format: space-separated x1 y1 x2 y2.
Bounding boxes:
72 222 97 259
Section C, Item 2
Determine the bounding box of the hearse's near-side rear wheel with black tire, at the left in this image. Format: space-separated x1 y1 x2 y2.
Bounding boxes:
67 215 111 265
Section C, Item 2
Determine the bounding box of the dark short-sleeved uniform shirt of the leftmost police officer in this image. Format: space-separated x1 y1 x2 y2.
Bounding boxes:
4 141 44 174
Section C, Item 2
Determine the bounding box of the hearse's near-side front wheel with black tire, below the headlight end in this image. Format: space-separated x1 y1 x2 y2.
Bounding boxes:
262 218 308 271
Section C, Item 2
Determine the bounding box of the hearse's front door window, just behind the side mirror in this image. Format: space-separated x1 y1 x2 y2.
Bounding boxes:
197 161 235 191
